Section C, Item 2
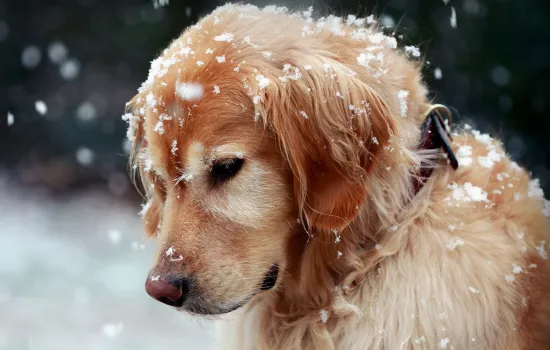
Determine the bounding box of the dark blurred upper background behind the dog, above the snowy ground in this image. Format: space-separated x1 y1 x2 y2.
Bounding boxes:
0 0 550 196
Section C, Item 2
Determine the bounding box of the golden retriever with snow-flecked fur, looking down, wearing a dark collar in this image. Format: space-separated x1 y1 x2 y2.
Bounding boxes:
123 4 550 350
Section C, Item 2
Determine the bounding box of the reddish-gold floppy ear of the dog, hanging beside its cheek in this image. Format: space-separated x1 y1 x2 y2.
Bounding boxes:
254 61 394 230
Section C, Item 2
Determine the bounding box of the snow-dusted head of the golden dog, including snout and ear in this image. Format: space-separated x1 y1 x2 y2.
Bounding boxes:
126 5 430 314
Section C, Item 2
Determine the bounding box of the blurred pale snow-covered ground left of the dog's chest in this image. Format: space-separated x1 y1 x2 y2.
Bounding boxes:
0 178 217 350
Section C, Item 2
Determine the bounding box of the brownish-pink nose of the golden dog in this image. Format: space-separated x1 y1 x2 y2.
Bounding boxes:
145 275 189 307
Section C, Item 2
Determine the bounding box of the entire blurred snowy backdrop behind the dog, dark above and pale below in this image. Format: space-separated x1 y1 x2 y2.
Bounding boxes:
0 0 550 350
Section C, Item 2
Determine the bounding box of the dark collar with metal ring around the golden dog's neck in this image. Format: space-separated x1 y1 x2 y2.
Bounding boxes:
413 105 458 194
